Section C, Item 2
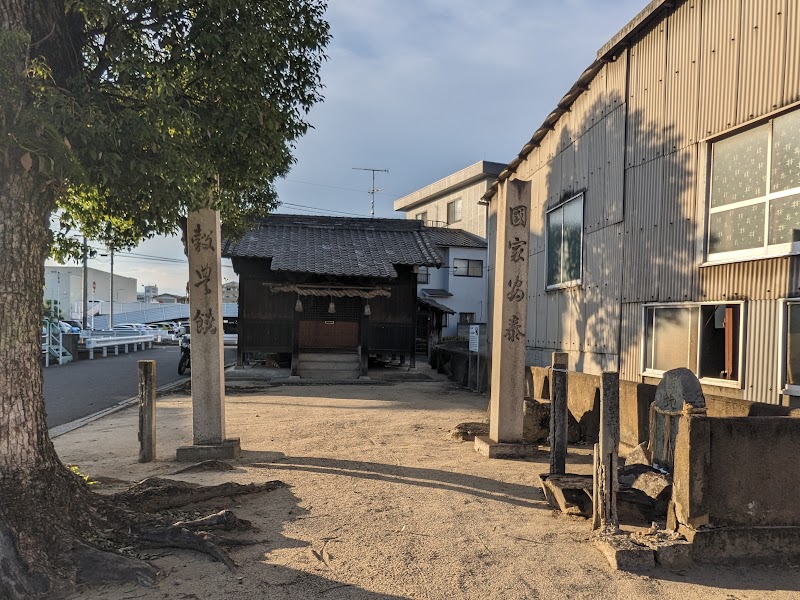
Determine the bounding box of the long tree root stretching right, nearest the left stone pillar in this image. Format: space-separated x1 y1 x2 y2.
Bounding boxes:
111 477 286 512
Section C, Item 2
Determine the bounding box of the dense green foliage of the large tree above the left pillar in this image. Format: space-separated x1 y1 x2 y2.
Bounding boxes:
0 0 329 257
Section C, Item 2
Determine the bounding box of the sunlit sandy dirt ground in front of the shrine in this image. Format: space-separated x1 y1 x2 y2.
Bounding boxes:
55 367 800 600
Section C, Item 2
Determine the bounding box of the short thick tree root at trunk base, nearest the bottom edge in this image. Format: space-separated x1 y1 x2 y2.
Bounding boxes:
72 542 158 587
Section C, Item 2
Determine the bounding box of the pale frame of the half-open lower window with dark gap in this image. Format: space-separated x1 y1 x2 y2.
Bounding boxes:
639 300 747 389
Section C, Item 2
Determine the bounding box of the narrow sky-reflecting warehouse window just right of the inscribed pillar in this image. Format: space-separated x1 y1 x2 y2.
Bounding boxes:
546 194 583 288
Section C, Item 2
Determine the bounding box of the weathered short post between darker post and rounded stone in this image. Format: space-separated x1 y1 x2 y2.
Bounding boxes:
592 373 619 533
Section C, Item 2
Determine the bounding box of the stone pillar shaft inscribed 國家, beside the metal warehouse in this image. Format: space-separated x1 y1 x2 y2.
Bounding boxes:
489 180 531 443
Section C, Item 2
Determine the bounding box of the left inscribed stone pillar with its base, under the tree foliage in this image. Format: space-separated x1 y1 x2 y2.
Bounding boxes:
177 208 239 461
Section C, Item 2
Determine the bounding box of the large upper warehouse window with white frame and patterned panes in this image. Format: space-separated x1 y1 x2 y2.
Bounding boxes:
707 111 800 261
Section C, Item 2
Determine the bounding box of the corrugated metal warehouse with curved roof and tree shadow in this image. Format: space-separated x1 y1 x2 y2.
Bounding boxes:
485 0 800 404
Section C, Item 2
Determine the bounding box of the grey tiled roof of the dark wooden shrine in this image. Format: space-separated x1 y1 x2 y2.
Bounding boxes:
222 215 442 279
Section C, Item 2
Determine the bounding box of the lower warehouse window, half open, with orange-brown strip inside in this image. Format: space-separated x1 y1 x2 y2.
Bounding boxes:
642 303 743 386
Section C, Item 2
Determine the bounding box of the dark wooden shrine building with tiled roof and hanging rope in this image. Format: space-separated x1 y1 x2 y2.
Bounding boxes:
222 215 442 377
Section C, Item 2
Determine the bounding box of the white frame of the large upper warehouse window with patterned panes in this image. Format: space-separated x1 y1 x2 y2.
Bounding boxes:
701 104 800 266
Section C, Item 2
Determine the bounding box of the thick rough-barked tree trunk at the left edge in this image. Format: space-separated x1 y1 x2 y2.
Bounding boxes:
0 0 95 599
